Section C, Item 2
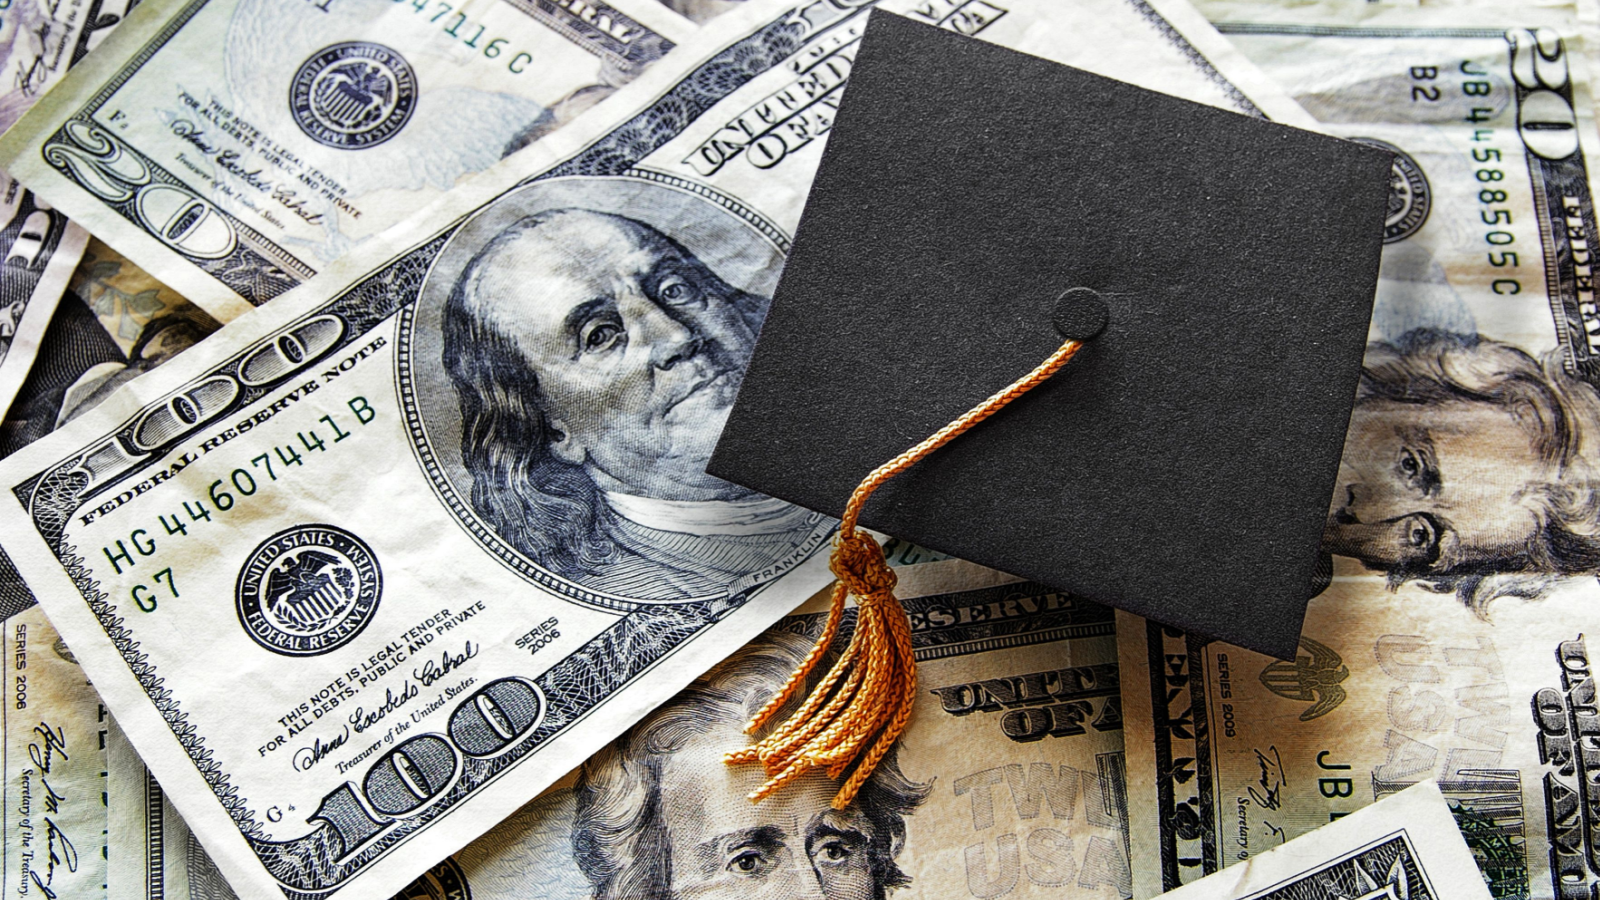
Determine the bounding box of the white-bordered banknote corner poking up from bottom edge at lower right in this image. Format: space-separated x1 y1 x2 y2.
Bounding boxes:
1170 783 1490 900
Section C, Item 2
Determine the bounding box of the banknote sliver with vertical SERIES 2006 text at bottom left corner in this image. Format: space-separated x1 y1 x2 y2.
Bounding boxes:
0 607 107 900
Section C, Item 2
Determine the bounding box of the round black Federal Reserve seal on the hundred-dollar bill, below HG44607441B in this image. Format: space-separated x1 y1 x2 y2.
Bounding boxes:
235 525 384 657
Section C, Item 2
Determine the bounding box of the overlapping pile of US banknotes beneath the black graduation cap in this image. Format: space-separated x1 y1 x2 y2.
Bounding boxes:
0 0 1600 900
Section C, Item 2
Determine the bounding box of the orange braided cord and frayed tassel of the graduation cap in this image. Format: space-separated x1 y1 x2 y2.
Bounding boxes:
723 340 1083 809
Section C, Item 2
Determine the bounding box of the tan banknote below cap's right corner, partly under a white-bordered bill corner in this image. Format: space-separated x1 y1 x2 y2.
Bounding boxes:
1117 575 1600 900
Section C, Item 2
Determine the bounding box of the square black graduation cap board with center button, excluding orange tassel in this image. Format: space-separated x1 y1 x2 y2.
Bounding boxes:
709 13 1390 658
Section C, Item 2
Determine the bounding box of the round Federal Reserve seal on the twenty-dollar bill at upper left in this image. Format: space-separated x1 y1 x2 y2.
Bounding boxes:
290 40 416 151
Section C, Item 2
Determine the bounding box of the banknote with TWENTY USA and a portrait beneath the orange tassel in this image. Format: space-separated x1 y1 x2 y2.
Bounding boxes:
109 560 1131 900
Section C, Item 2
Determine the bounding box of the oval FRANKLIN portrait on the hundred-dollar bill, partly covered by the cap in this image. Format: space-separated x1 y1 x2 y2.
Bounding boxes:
400 179 832 602
